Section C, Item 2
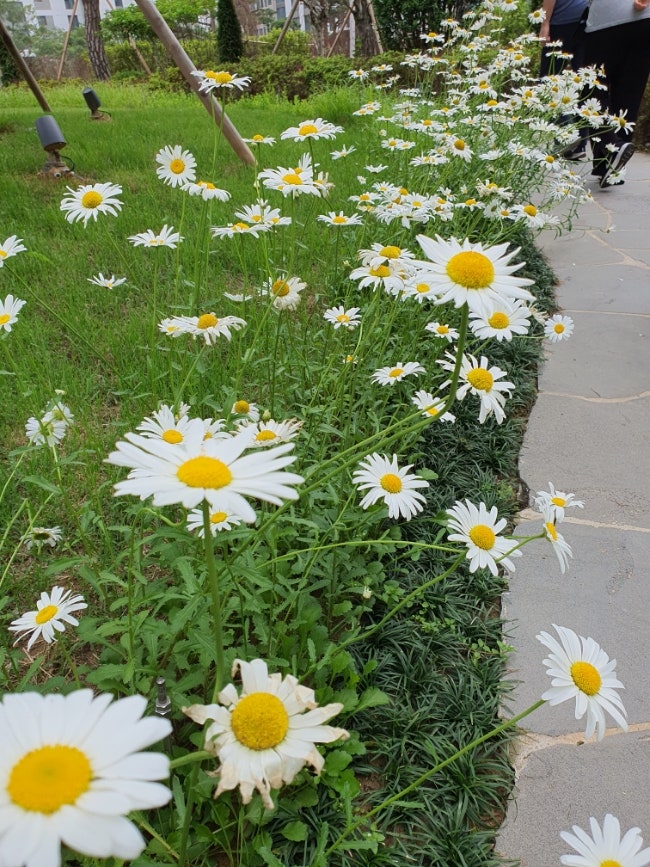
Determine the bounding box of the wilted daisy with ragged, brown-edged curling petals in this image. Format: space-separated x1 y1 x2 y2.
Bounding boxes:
183 659 349 810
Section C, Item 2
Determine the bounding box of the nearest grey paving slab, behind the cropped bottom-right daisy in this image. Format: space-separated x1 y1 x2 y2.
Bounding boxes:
496 729 650 867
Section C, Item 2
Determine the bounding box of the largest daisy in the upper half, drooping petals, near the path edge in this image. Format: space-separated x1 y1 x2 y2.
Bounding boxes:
418 235 534 313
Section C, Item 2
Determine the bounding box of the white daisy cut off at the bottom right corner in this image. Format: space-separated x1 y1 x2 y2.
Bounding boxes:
560 813 650 867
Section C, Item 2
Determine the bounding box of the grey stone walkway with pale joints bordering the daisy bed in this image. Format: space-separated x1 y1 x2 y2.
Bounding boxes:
497 153 650 867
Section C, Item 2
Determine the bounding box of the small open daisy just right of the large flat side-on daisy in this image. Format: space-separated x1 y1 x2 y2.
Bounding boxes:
352 452 429 521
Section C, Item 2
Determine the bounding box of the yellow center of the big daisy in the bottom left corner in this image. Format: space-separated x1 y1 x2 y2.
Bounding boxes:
7 745 92 815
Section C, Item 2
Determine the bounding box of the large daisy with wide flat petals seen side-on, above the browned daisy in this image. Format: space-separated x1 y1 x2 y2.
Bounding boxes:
106 419 303 524
